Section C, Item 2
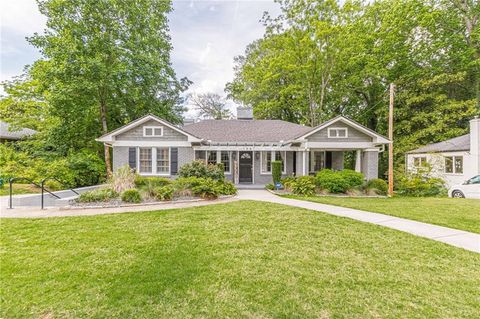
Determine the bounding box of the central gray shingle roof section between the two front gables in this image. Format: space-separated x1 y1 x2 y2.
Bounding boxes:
182 120 312 142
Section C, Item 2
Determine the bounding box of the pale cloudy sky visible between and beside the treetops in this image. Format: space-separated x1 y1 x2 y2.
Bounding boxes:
0 0 279 116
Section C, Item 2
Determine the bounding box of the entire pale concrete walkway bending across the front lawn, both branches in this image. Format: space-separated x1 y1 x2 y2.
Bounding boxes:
0 189 480 253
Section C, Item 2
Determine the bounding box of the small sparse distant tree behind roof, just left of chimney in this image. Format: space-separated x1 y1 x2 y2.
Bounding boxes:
188 93 232 120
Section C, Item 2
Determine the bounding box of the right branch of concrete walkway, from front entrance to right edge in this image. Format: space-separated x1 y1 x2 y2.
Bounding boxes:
237 190 480 253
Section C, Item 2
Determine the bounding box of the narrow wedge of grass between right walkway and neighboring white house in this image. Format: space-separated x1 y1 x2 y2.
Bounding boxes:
286 195 480 233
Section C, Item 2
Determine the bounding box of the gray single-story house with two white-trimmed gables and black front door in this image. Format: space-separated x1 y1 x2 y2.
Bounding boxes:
97 108 389 184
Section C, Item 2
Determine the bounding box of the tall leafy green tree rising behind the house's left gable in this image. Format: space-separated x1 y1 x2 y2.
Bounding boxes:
29 0 190 174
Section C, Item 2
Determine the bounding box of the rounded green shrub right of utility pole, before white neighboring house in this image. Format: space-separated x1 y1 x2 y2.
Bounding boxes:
397 173 447 197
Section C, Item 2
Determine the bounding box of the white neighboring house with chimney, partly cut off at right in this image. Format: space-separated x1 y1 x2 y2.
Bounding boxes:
406 118 480 187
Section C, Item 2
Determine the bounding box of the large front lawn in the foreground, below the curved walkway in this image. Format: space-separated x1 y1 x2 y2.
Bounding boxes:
0 201 480 318
